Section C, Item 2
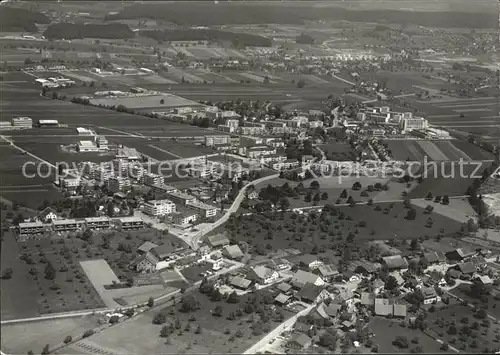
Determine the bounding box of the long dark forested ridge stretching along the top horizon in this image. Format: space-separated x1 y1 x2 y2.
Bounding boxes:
107 3 498 28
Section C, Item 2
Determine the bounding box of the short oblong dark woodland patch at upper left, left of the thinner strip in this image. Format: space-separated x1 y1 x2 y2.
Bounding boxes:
44 23 135 39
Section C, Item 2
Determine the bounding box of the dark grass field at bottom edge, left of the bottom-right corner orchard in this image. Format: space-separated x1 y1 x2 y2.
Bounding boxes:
368 317 452 354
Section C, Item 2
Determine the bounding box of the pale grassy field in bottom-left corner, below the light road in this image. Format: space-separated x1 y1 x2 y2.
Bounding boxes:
1 315 98 354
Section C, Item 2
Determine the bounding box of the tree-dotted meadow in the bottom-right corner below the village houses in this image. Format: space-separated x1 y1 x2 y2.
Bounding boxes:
427 305 500 354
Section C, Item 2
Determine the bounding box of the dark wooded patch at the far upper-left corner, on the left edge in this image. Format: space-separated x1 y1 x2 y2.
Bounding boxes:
0 6 50 32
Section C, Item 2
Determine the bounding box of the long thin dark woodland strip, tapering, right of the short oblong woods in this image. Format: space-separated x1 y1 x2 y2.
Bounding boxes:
140 29 272 47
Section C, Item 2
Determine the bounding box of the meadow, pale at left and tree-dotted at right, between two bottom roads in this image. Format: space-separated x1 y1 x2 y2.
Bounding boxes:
61 291 291 354
